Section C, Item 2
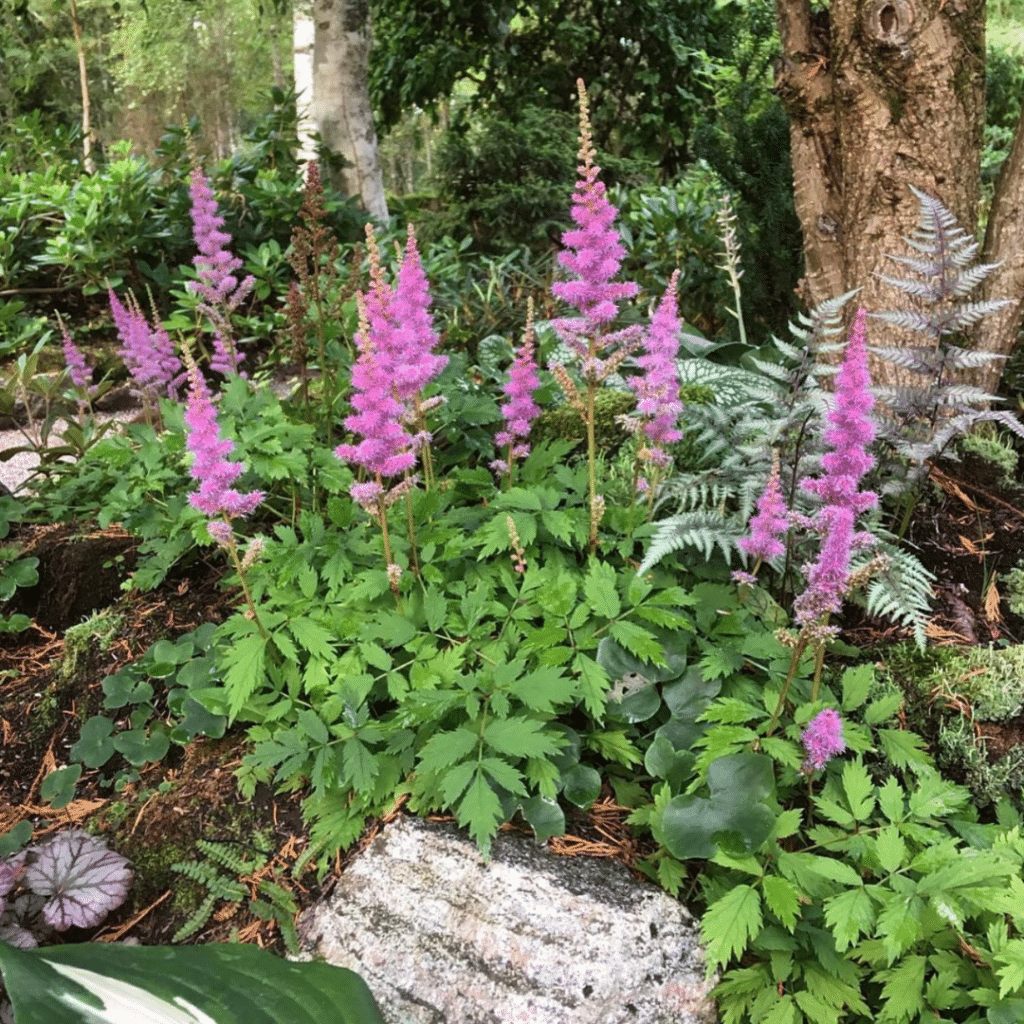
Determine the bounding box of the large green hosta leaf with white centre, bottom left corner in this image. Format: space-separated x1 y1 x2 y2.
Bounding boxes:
0 943 384 1024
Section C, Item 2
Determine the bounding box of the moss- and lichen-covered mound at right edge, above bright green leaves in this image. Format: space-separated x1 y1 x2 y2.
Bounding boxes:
888 646 1024 808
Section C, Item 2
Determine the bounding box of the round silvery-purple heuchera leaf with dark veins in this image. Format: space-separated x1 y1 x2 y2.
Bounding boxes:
23 829 132 932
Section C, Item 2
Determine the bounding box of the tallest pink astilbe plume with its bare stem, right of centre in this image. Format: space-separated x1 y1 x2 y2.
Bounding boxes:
549 79 640 551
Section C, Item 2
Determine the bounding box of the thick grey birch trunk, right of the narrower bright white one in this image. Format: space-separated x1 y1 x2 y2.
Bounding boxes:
310 0 388 221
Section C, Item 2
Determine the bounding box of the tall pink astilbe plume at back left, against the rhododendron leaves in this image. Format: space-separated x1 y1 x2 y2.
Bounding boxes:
185 168 256 374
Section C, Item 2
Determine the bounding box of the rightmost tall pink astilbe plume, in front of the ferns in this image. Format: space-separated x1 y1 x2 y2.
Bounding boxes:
794 307 878 626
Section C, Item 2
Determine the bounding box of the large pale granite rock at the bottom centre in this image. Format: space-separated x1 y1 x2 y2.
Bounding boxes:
299 818 718 1024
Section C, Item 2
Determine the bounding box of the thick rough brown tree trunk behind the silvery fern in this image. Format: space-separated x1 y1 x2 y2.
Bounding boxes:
776 0 1024 387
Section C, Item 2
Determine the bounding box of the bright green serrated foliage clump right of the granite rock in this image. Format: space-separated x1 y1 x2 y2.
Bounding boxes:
675 666 1024 1024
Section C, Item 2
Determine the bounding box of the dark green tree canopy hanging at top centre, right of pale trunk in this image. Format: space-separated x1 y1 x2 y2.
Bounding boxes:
370 0 737 174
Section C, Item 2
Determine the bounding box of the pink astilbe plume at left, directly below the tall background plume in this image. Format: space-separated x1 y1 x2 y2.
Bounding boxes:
184 364 265 520
